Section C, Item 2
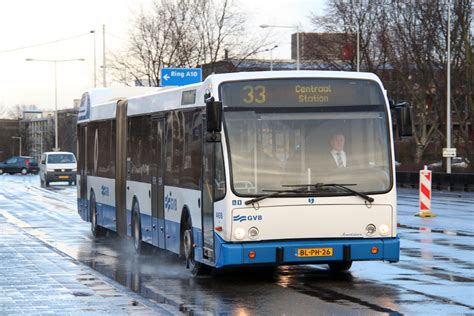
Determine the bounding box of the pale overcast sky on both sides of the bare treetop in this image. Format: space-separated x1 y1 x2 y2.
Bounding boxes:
0 0 325 113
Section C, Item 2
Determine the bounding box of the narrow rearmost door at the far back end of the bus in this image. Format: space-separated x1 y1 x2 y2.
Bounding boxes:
77 125 91 221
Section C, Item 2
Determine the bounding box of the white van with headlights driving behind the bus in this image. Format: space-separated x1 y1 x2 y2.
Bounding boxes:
39 151 77 187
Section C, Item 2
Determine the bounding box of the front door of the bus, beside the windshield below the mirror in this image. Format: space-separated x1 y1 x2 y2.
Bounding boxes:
201 137 216 262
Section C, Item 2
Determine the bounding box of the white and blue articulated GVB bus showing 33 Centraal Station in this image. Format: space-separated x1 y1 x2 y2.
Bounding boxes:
77 71 400 274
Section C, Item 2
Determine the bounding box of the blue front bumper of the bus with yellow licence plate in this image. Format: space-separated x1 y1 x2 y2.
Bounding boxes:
215 235 400 268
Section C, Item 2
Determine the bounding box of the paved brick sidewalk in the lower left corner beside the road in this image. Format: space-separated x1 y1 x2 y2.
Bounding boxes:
0 214 173 315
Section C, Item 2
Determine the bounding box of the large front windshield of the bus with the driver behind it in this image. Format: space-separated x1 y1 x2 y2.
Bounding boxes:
223 79 393 196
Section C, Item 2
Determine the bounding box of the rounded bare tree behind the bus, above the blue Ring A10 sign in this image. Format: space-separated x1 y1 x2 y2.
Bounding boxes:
111 0 267 85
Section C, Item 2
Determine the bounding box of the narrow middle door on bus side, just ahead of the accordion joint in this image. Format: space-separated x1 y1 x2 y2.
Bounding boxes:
151 117 165 249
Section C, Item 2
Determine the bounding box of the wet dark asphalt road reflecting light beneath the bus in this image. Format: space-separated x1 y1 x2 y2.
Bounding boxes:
0 175 474 315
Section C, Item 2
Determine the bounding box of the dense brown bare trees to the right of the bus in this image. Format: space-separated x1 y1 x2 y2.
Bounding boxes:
311 0 474 167
